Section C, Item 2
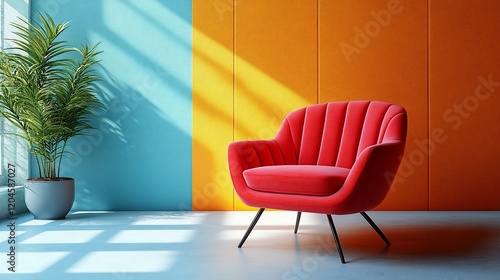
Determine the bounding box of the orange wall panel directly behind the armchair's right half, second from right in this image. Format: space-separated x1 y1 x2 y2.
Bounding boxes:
319 0 428 210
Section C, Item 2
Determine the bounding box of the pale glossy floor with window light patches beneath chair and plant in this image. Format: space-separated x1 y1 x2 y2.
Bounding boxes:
0 211 500 280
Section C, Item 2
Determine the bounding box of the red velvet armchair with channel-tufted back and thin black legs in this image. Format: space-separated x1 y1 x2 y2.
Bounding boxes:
228 101 407 263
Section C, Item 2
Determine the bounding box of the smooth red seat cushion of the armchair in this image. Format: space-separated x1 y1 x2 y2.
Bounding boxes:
243 165 350 196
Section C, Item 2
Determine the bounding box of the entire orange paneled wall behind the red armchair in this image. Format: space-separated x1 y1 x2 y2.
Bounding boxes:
193 0 500 210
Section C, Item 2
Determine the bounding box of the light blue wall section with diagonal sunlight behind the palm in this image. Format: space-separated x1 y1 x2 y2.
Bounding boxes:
32 0 192 210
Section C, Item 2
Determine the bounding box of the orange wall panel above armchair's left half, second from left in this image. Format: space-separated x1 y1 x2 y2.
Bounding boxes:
234 0 317 209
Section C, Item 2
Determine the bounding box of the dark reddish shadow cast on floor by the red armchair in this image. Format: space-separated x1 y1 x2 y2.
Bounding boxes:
295 225 500 262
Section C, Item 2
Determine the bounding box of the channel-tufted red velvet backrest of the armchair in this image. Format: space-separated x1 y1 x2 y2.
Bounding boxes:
275 101 407 168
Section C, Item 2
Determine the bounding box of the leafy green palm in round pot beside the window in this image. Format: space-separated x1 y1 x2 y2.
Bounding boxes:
0 14 102 219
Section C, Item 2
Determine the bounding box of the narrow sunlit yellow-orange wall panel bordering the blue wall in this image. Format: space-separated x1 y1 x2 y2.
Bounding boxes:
192 0 234 210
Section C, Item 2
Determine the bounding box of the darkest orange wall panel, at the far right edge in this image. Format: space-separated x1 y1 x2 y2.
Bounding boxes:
429 0 500 210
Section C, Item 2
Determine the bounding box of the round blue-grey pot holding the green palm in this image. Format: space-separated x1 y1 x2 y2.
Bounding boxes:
25 178 75 220
